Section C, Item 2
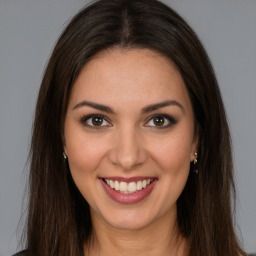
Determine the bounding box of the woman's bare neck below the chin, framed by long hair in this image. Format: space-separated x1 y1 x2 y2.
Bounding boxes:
85 210 188 256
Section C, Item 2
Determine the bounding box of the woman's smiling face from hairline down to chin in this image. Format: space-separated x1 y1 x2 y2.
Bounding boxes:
64 49 197 230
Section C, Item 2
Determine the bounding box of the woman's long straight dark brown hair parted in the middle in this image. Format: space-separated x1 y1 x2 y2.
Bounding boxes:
26 0 245 256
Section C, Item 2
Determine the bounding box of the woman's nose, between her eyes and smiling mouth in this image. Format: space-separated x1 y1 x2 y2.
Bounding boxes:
109 128 148 170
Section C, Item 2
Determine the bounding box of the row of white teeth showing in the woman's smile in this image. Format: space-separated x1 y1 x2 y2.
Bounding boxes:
104 179 153 194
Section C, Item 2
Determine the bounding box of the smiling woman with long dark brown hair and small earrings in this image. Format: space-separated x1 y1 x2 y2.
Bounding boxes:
14 0 245 256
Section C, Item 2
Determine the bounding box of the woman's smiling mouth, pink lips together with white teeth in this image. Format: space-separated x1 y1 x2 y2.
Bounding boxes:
99 177 158 204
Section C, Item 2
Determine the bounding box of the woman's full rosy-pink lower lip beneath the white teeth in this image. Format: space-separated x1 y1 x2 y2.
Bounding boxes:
100 179 157 204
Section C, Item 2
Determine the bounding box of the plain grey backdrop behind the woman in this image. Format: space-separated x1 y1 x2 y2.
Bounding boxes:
0 0 256 256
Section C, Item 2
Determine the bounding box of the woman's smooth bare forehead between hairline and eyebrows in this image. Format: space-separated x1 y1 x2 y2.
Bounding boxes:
70 49 190 112
